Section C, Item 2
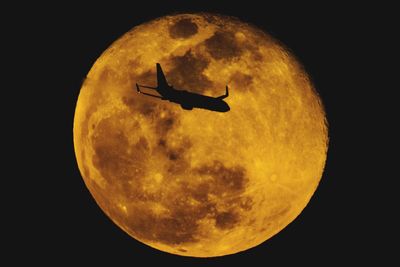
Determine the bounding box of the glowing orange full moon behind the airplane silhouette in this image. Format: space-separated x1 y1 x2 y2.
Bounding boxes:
73 13 328 257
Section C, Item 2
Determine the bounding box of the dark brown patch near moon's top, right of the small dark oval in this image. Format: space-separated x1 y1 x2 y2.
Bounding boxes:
204 31 242 60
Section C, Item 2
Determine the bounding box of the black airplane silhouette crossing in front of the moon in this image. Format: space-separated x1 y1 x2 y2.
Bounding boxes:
136 63 230 112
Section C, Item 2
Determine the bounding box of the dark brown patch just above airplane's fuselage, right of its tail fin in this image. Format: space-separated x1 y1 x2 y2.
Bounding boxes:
166 50 212 93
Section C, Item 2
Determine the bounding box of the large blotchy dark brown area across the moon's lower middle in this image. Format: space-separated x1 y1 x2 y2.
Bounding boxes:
123 160 252 245
